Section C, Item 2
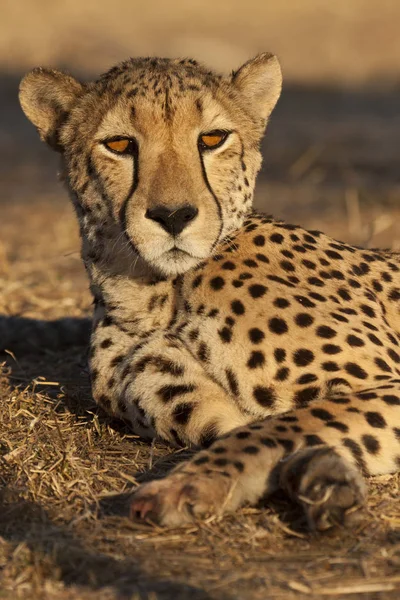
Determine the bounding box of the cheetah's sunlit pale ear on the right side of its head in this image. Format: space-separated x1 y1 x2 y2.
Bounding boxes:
232 52 282 119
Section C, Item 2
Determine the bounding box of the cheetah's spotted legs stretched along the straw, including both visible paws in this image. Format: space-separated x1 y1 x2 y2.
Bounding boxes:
131 392 400 530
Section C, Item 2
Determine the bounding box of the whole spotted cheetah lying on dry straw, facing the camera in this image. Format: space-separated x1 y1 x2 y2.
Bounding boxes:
20 53 400 531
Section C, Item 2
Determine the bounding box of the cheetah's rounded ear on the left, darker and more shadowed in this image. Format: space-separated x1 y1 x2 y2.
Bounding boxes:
19 67 83 151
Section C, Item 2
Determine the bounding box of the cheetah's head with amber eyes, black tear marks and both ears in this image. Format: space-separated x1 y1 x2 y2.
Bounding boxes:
20 54 281 276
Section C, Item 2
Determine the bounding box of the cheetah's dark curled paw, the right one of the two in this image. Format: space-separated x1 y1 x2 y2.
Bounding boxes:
281 448 366 531
